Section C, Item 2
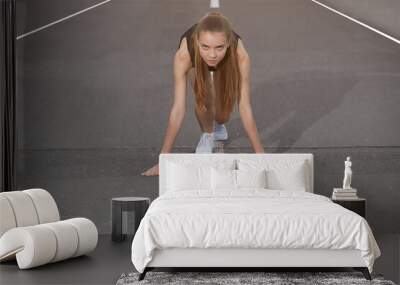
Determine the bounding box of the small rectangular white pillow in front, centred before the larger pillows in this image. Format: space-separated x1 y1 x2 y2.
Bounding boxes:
211 168 267 190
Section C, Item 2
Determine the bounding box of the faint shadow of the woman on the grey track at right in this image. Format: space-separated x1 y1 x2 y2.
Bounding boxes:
226 71 357 148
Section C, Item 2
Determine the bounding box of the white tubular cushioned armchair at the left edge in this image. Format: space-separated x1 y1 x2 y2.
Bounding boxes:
0 189 98 269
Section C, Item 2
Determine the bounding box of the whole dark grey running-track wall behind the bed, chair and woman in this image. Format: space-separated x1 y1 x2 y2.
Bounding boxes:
17 0 400 233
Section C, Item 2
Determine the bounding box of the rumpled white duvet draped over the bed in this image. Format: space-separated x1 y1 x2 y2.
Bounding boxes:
132 189 380 272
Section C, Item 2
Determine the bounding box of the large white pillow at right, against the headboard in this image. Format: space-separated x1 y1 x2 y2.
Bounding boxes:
238 159 310 192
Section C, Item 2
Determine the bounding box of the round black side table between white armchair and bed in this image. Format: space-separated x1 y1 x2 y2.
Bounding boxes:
111 197 150 241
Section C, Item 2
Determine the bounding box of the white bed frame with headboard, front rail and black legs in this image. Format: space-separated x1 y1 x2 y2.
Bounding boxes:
139 153 371 280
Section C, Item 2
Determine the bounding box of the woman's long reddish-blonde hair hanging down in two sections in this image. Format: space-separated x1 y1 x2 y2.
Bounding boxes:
191 12 241 117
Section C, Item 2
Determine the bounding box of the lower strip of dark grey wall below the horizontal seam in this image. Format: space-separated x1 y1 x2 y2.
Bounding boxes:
18 148 400 233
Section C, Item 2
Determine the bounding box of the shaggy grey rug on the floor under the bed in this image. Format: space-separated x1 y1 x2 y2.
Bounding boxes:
117 271 395 285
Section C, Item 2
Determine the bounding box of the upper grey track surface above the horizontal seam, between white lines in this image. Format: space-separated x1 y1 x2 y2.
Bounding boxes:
18 1 400 149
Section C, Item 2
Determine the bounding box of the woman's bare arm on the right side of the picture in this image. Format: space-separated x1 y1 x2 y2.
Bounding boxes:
237 39 264 153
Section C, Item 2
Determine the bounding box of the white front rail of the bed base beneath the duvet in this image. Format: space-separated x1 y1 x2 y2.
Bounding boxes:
147 248 366 267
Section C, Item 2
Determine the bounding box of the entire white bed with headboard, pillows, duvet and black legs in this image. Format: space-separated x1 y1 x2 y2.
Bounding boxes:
131 153 380 280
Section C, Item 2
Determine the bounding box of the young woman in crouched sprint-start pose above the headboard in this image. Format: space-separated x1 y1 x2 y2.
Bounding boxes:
142 12 264 176
